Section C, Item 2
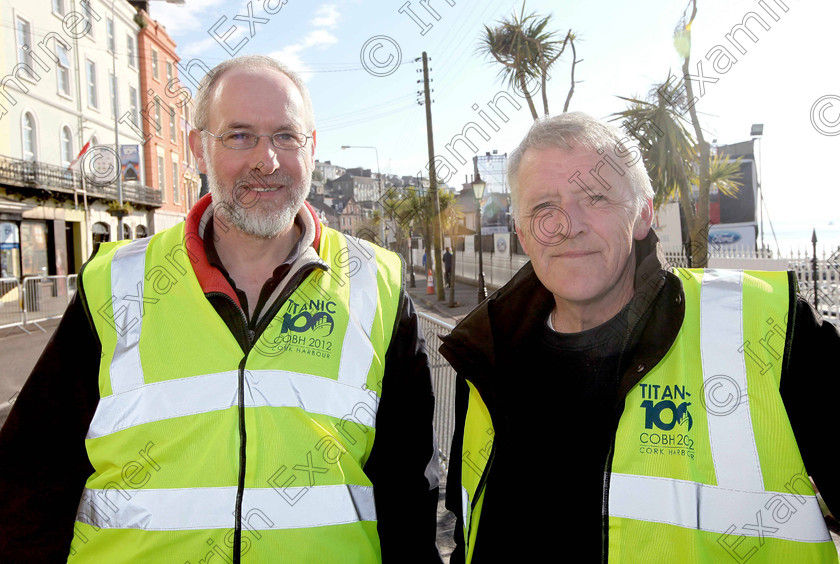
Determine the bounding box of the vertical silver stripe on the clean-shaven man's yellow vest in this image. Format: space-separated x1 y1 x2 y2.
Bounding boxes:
700 270 764 491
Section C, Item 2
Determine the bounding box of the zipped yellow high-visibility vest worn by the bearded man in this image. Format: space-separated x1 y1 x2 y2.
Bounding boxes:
69 223 402 564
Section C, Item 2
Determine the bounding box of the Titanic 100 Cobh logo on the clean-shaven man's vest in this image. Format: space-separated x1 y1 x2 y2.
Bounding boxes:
639 384 694 459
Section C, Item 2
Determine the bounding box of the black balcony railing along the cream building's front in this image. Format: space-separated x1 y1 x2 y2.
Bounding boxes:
0 155 161 207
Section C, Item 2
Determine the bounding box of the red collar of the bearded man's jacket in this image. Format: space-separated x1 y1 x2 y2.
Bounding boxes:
185 194 321 307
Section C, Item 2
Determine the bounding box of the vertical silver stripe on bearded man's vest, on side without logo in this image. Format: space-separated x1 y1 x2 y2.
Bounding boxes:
111 237 151 394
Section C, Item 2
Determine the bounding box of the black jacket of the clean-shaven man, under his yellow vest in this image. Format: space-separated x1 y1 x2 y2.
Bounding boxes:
440 232 840 564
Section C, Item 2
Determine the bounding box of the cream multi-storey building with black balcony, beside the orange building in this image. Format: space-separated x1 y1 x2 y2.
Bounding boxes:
0 0 160 278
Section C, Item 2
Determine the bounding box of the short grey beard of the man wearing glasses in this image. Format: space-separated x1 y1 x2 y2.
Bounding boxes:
207 162 311 239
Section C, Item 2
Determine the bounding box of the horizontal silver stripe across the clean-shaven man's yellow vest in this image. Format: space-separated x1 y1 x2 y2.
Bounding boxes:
610 473 831 542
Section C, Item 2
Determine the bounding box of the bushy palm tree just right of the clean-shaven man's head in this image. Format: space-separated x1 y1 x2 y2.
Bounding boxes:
613 75 741 267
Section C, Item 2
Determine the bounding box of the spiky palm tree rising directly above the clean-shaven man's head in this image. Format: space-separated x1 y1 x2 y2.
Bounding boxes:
478 0 579 121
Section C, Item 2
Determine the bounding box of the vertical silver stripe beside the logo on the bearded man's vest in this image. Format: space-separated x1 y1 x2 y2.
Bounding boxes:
338 236 378 388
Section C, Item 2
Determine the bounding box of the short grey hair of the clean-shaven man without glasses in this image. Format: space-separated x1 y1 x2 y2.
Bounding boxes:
507 112 653 222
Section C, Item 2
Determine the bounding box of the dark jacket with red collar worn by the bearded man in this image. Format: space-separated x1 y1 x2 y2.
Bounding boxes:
0 196 439 562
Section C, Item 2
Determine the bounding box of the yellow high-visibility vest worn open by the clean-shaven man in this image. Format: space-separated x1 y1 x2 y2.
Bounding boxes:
461 269 838 564
